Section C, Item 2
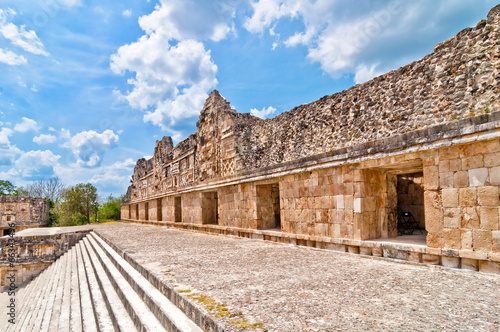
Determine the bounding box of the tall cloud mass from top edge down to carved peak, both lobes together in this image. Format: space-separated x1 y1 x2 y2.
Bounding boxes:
111 1 226 130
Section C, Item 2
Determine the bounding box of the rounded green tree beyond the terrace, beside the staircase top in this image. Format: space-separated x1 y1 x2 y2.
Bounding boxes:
58 183 99 226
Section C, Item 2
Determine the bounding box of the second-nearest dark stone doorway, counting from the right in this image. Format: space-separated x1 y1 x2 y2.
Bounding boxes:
256 183 281 231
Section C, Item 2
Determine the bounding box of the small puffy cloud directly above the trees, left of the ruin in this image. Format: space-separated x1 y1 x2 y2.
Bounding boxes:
63 129 118 167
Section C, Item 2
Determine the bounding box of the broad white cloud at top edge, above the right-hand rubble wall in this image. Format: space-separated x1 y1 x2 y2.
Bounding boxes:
244 0 408 78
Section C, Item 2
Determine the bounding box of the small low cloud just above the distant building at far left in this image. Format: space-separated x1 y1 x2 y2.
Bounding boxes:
13 150 61 179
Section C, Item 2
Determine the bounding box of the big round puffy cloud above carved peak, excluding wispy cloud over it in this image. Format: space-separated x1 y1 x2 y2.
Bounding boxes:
111 27 217 129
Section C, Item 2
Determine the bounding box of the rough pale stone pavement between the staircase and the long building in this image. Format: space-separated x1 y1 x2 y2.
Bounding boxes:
96 224 500 331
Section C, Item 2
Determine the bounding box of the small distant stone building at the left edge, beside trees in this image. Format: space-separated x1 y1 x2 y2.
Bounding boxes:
0 196 49 236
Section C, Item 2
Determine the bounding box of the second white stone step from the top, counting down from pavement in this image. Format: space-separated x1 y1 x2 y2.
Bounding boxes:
87 237 166 331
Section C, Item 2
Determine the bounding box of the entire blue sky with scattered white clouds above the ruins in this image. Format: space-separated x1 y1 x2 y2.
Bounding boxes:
0 0 497 197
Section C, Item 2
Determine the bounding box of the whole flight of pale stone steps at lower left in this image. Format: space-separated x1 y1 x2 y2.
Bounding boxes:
0 232 202 332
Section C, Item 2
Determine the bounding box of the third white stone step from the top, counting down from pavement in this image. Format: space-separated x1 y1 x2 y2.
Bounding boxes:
83 237 137 331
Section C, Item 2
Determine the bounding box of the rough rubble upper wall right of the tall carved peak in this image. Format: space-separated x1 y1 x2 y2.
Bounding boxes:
237 6 500 170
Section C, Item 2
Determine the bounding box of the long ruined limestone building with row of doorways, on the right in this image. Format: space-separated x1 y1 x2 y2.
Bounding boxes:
122 6 500 273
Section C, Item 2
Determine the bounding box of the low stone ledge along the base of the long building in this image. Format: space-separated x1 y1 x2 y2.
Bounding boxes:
122 219 500 273
